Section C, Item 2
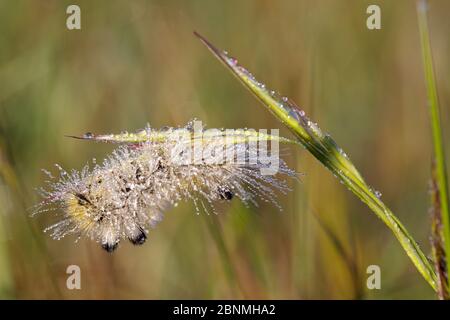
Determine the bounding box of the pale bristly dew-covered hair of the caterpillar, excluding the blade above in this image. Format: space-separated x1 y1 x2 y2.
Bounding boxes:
35 122 296 252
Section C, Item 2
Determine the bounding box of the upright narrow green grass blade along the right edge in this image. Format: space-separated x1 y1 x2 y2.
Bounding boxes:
417 1 450 292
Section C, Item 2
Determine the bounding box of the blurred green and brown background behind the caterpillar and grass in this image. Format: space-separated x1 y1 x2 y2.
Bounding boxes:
0 0 450 299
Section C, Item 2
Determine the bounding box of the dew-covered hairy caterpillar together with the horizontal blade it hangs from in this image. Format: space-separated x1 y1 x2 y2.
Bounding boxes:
34 121 298 252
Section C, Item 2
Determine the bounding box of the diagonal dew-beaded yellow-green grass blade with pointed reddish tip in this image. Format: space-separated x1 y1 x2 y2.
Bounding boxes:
195 33 436 290
